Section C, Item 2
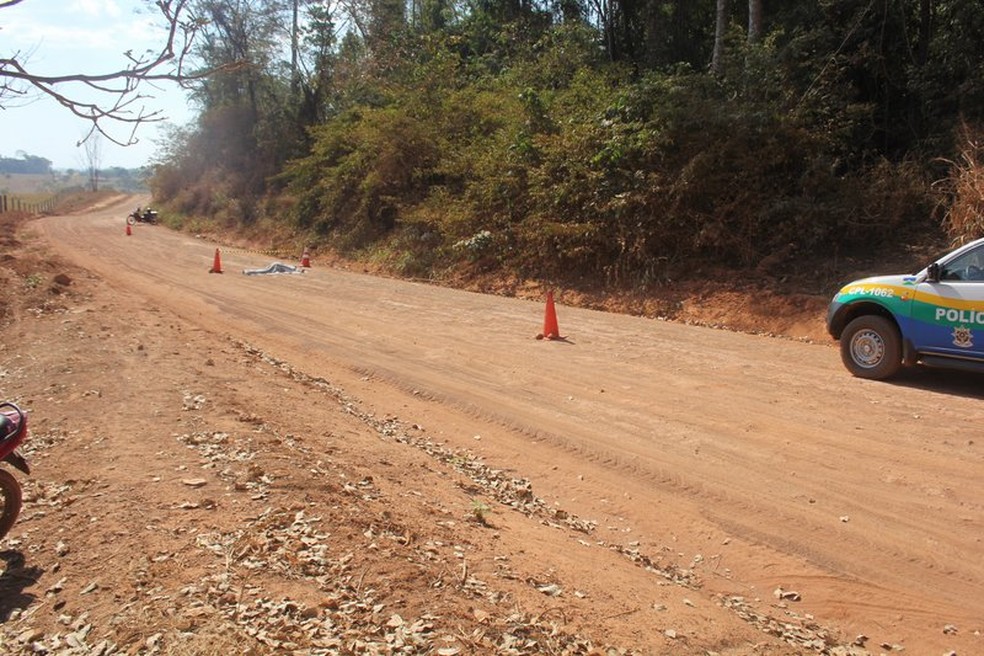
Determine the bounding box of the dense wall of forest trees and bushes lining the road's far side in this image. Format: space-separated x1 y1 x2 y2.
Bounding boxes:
153 0 984 284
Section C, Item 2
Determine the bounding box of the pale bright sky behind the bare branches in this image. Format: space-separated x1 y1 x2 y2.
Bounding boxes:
0 0 194 170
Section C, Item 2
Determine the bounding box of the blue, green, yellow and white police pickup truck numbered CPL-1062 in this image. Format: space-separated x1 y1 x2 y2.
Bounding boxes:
827 239 984 380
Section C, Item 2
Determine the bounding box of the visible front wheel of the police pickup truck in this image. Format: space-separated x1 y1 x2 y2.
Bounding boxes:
840 314 902 380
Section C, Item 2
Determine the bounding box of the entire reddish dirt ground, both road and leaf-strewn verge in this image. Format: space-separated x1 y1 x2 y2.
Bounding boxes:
0 200 984 656
